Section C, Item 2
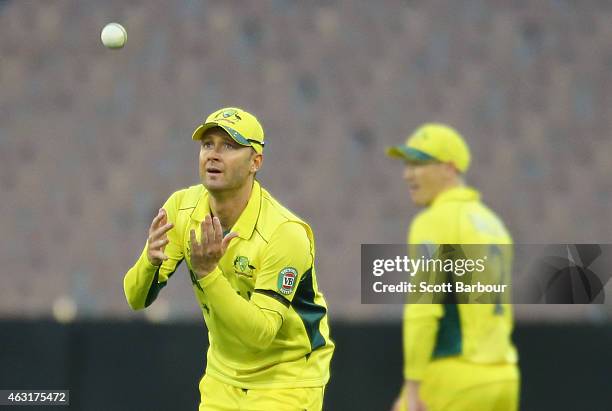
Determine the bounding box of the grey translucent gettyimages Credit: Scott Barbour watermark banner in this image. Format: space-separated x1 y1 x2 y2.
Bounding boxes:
361 244 612 304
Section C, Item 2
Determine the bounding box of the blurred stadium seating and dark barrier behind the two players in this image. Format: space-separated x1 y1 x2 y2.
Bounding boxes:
0 0 612 411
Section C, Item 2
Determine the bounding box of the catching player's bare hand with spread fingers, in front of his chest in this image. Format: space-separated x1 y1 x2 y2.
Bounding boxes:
189 215 238 278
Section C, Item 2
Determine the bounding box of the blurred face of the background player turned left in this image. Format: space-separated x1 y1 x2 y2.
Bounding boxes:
404 162 453 206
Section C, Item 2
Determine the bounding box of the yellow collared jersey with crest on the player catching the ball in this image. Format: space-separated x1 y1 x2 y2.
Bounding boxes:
124 181 334 389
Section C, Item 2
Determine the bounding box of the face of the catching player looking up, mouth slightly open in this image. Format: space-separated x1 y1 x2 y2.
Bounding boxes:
199 127 262 193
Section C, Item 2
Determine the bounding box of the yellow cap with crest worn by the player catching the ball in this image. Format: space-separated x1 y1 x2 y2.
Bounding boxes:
191 107 265 153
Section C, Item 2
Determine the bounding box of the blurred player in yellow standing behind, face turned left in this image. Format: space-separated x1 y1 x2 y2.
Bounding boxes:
387 124 520 411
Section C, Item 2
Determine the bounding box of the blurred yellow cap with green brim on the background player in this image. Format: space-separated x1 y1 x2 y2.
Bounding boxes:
386 123 471 173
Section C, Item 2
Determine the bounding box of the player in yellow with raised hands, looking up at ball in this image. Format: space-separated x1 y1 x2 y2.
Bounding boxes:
124 107 334 411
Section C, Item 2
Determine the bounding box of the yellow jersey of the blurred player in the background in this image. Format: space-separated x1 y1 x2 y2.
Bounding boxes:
403 187 517 380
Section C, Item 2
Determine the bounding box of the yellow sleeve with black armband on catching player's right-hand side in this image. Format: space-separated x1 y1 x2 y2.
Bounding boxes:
196 222 313 350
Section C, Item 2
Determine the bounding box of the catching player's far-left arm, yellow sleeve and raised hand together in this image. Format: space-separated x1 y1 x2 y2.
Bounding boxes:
123 195 183 310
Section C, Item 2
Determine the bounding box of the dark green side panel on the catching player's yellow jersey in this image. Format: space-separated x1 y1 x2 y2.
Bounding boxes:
291 268 327 351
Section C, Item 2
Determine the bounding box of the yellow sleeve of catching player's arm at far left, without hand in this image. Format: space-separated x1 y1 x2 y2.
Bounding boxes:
123 193 183 310
